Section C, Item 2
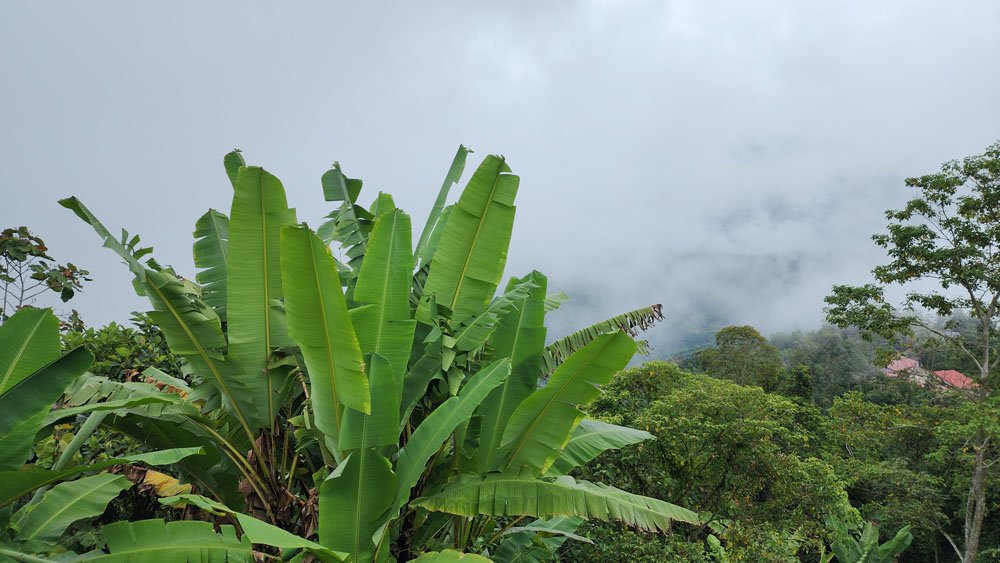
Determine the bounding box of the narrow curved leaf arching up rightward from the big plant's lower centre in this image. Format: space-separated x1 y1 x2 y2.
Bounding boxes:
394 358 510 512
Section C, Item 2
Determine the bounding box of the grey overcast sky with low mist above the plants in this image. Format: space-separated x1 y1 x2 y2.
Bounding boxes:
0 0 1000 356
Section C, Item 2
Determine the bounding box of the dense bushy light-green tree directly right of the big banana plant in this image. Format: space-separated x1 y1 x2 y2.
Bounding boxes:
571 362 855 561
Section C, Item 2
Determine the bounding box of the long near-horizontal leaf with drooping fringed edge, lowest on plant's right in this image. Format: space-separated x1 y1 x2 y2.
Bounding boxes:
410 473 699 532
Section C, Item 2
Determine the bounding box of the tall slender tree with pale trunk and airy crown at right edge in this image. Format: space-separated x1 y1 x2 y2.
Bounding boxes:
826 143 1000 563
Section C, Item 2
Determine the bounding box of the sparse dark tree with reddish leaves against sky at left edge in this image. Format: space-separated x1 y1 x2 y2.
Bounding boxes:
0 227 90 320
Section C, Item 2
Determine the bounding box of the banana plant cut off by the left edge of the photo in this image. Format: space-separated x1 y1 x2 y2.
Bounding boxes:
0 308 217 560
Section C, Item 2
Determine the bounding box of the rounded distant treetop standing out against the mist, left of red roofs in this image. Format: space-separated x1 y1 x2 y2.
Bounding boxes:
698 326 785 391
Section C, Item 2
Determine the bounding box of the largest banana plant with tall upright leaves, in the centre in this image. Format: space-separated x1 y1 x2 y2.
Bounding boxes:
61 147 698 562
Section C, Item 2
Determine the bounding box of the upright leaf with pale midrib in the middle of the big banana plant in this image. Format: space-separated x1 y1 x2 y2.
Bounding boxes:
351 205 416 391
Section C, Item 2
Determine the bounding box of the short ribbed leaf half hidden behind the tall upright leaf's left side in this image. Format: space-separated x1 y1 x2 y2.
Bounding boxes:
194 209 229 321
